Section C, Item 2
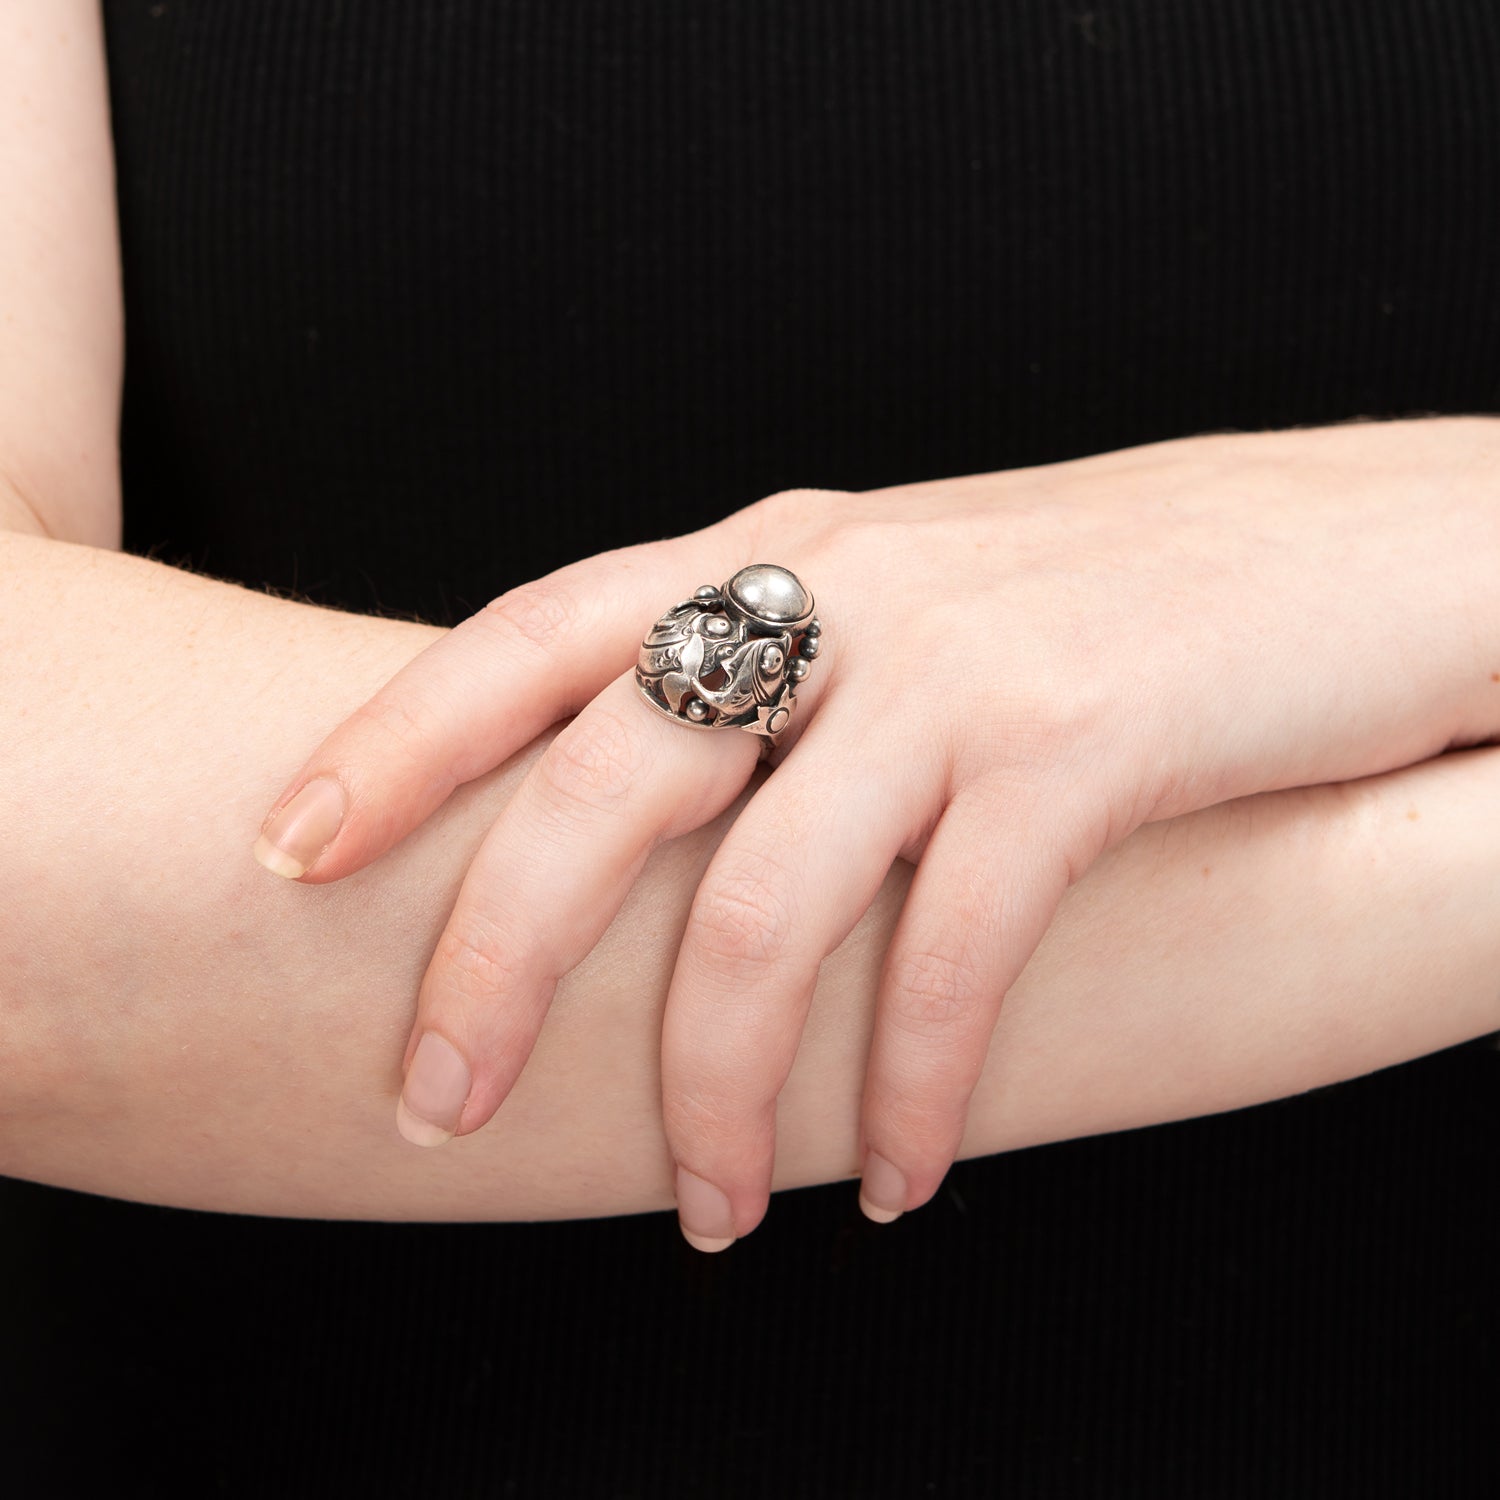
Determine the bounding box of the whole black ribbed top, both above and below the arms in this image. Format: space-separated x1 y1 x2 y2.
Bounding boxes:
0 0 1500 1500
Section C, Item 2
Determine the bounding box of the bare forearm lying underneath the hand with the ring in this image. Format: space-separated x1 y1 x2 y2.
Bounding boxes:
0 537 1500 1218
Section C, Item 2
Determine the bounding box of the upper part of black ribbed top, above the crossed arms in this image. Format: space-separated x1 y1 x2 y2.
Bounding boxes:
99 0 1500 624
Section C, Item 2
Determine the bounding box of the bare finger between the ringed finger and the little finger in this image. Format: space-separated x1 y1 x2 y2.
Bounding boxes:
662 692 933 1251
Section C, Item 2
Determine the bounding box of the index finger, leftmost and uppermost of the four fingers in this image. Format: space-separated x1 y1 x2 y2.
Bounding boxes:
255 530 725 885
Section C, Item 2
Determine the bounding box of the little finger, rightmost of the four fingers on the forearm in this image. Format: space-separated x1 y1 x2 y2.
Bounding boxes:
860 788 1070 1224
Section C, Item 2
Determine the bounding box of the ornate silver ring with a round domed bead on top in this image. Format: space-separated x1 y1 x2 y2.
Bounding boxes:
636 563 824 756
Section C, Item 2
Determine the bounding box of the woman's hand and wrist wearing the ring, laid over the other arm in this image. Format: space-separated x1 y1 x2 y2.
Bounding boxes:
257 419 1500 1248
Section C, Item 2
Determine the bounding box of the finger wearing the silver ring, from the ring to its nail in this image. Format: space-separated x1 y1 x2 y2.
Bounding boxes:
396 669 759 1146
